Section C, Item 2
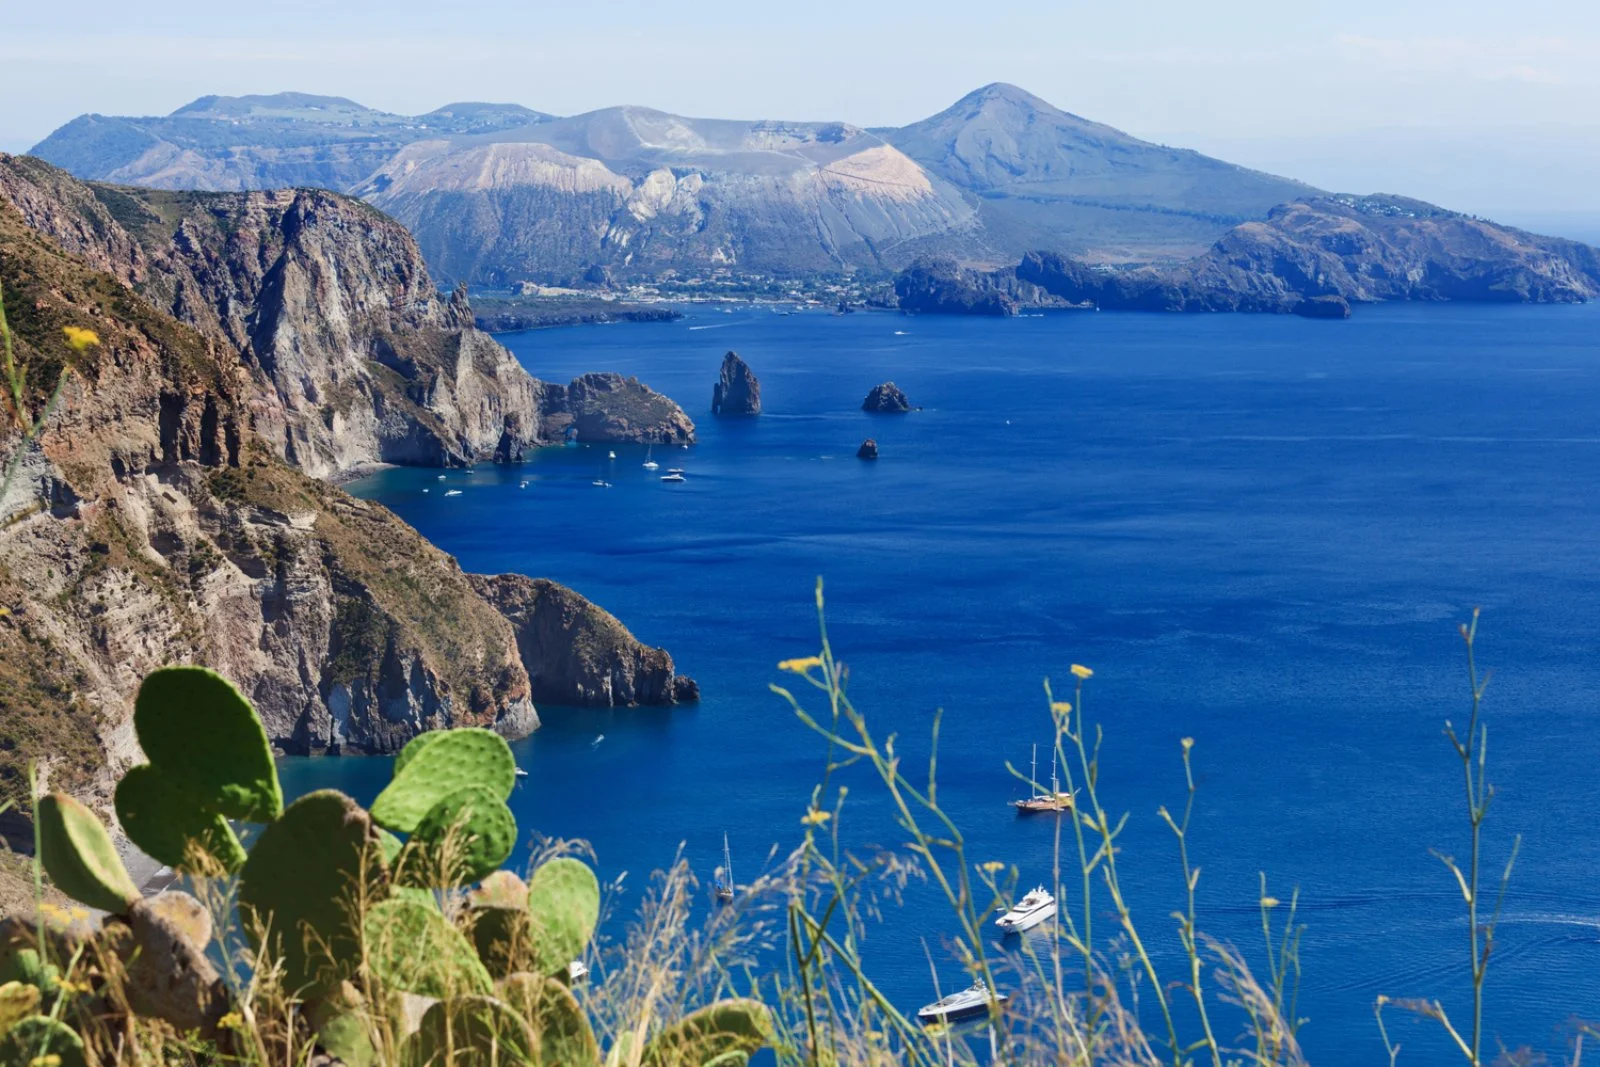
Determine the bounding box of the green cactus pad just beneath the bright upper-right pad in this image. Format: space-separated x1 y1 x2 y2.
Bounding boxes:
397 785 517 888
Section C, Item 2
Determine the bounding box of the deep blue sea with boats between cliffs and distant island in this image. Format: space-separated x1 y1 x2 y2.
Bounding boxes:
285 306 1600 1064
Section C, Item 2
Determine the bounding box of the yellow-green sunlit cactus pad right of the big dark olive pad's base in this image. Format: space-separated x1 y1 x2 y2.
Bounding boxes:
365 897 491 998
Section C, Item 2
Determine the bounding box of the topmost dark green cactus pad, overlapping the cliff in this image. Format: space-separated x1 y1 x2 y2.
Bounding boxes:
133 667 283 822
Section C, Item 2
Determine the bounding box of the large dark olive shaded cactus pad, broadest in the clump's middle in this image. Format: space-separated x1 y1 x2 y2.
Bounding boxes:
238 789 387 995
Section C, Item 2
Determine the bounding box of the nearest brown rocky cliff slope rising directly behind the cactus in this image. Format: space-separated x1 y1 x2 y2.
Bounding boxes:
0 156 691 819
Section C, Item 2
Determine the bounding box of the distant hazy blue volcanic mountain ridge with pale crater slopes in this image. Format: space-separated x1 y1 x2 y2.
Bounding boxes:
34 83 1315 285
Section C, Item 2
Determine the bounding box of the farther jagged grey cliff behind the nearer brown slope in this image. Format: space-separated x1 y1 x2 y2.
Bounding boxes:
0 157 693 477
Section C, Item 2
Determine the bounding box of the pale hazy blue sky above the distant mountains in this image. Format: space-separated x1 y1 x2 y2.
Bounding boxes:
0 0 1600 225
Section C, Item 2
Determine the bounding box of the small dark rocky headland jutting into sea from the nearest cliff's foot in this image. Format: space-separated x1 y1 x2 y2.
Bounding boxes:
470 574 699 707
